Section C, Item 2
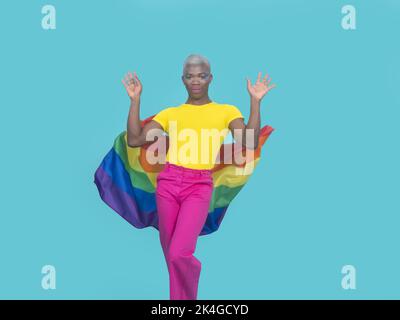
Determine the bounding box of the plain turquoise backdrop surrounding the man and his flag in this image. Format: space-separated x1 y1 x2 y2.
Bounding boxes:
0 0 400 299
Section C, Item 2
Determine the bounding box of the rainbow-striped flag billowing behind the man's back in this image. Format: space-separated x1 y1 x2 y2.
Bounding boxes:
94 115 274 235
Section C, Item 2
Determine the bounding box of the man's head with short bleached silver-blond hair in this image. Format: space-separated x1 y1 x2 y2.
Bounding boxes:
182 54 213 100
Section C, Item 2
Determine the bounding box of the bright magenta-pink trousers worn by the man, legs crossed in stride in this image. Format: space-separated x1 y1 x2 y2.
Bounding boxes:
156 162 213 300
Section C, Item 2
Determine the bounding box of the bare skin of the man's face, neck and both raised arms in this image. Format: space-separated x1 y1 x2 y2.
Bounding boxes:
122 64 276 149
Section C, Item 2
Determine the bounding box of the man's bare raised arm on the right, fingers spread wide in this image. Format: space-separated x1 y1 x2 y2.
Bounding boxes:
229 72 276 149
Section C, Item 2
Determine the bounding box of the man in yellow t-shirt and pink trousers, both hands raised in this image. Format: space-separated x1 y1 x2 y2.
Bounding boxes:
118 55 275 300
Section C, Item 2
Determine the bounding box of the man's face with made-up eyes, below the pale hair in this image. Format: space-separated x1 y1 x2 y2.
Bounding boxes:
182 64 212 99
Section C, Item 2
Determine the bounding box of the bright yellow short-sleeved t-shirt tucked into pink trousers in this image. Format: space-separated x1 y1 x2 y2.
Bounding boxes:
152 102 244 169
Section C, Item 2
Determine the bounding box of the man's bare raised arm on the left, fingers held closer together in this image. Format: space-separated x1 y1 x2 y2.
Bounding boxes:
122 72 162 147
